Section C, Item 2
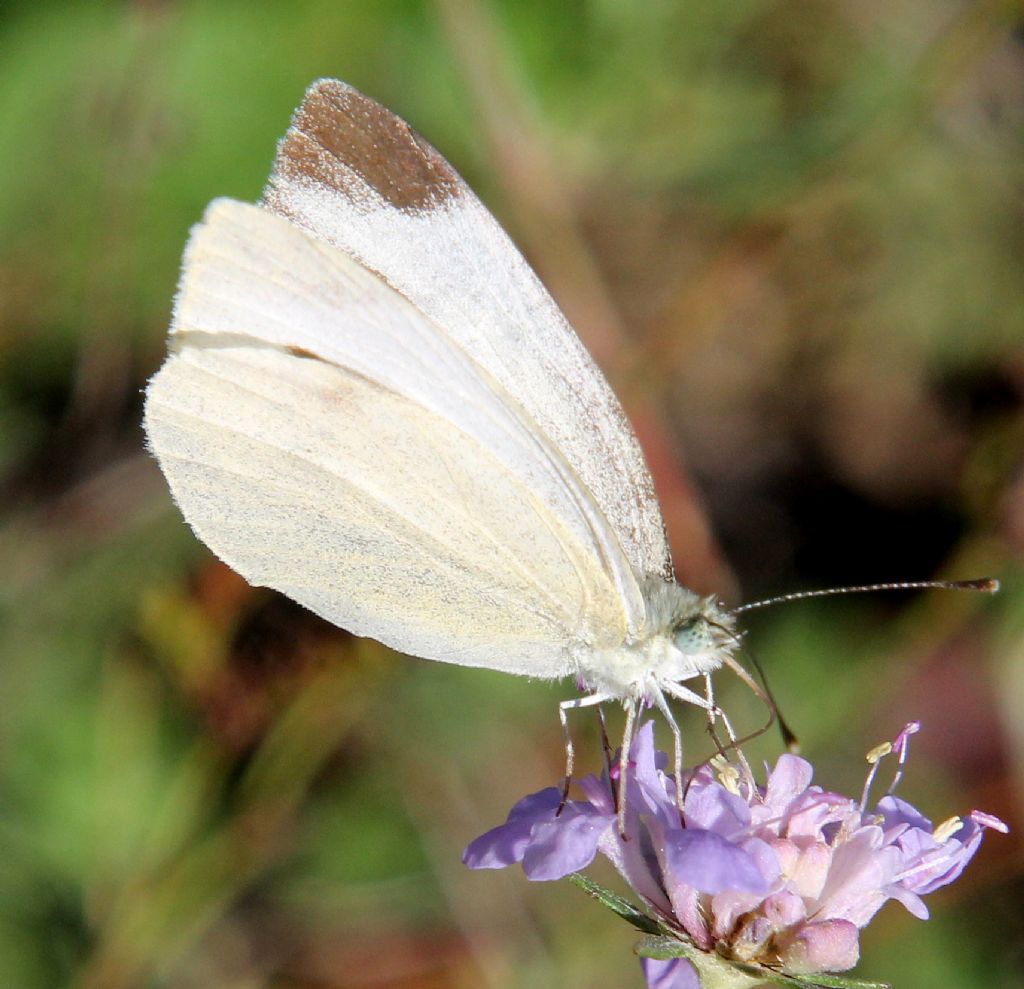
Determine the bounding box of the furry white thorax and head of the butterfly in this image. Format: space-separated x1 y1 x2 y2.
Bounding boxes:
575 577 736 702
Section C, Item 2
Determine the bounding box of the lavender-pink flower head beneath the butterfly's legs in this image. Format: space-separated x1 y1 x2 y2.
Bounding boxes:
463 722 1007 989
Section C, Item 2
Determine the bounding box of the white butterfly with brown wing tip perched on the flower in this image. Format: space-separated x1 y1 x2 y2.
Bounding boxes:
145 80 736 802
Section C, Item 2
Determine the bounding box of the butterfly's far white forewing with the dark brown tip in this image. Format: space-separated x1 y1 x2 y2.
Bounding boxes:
264 80 672 629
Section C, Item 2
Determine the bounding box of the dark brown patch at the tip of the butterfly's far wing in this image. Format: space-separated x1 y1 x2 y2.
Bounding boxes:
264 79 465 211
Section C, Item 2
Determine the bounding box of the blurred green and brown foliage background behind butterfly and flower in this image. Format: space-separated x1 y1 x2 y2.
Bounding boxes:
0 0 1024 989
